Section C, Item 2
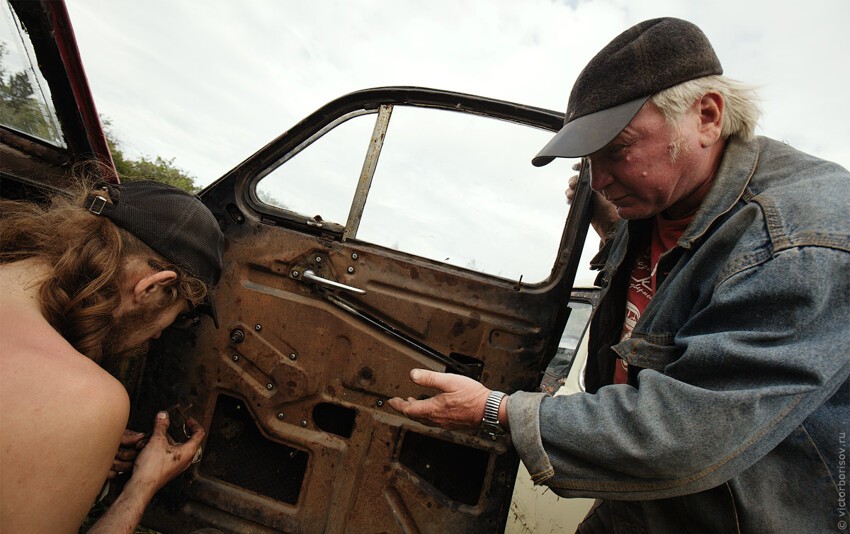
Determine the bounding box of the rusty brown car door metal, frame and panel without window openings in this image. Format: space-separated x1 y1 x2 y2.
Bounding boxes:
131 87 590 532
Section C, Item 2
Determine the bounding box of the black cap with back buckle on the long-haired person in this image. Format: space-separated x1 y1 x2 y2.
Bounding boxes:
85 180 224 327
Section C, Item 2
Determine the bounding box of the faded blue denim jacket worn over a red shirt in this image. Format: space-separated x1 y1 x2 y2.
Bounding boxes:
508 137 850 533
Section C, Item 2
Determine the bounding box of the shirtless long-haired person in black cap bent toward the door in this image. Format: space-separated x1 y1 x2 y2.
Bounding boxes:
0 182 224 533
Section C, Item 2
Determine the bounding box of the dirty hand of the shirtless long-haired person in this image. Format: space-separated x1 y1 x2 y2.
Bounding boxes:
131 412 204 496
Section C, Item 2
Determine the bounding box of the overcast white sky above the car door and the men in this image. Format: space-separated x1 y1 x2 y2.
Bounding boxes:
66 0 850 186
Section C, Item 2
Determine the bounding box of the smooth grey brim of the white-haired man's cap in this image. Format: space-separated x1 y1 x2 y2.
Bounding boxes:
531 96 649 167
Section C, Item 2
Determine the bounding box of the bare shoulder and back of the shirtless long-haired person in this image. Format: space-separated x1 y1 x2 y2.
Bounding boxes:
0 324 129 532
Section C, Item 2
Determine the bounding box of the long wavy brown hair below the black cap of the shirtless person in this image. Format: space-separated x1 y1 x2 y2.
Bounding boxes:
0 180 208 362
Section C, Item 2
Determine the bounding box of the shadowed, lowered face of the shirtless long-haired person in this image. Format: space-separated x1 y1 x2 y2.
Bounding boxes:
110 301 189 354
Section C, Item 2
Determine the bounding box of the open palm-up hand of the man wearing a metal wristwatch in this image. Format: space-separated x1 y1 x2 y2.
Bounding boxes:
389 369 490 430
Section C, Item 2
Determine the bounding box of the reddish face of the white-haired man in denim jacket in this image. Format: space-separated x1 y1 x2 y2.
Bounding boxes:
589 102 697 219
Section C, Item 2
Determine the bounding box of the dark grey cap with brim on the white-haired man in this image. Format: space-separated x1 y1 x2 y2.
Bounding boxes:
531 17 723 167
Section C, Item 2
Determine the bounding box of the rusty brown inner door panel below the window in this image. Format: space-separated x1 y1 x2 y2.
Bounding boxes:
132 216 568 532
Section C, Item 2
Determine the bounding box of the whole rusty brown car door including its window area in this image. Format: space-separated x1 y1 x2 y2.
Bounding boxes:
125 87 589 533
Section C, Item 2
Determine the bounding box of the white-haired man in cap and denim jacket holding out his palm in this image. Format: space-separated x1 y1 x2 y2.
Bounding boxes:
390 18 850 533
